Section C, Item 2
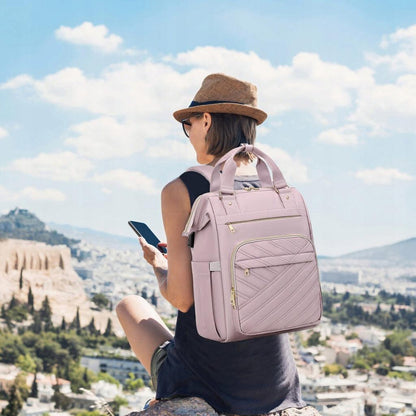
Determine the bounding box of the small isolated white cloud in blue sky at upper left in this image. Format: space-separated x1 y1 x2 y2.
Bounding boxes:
55 22 123 53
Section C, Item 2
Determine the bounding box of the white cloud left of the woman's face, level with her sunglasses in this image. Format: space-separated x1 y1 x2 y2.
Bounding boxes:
65 117 148 159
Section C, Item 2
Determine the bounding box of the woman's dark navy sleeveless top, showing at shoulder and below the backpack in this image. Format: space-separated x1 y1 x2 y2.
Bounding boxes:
156 172 305 415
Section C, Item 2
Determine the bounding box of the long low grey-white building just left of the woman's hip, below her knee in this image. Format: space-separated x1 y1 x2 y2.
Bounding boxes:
81 356 150 384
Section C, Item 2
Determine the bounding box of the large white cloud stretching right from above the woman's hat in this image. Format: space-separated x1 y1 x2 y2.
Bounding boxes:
166 46 374 118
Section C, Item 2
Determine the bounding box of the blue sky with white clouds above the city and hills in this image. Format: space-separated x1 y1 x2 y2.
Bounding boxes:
0 0 416 255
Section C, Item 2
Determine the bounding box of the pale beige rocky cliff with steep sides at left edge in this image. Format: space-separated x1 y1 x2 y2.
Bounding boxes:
0 239 119 331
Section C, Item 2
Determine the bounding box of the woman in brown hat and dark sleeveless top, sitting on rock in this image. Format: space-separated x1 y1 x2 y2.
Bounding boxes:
117 74 305 415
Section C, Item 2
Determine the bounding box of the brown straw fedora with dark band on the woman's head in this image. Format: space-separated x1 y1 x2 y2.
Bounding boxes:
173 74 267 124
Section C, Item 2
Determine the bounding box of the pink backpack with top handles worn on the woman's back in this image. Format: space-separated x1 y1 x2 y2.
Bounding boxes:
182 144 322 342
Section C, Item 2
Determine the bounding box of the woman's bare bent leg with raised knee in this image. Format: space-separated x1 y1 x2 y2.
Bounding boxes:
116 295 173 375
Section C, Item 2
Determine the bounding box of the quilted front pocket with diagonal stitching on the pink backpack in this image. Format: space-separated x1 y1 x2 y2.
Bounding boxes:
231 234 322 335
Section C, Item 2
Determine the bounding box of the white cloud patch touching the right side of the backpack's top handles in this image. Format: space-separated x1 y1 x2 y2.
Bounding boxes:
256 143 309 184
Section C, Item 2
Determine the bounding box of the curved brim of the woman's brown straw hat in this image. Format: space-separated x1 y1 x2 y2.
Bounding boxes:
173 103 267 125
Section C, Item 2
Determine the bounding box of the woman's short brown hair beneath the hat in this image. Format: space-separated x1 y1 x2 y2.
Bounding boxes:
205 113 257 160
